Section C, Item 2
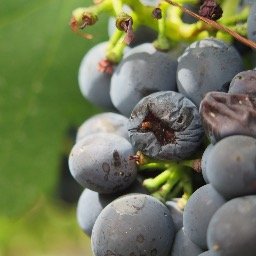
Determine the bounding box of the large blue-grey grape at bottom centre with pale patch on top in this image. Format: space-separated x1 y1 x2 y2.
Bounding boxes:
91 194 174 256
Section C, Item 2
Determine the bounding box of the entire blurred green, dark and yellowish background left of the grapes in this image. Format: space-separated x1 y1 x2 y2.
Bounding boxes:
0 0 107 256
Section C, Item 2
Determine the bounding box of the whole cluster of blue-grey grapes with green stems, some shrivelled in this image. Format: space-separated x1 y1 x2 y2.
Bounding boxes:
69 0 256 256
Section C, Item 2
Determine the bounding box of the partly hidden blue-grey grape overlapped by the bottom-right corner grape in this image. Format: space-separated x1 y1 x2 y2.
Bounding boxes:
183 184 226 249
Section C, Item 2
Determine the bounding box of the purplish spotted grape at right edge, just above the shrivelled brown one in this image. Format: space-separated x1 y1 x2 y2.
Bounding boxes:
228 70 256 95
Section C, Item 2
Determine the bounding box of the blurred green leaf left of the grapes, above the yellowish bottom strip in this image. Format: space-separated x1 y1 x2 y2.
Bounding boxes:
0 0 107 216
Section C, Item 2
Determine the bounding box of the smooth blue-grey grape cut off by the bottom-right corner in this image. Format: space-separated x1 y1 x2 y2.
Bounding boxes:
207 195 256 256
